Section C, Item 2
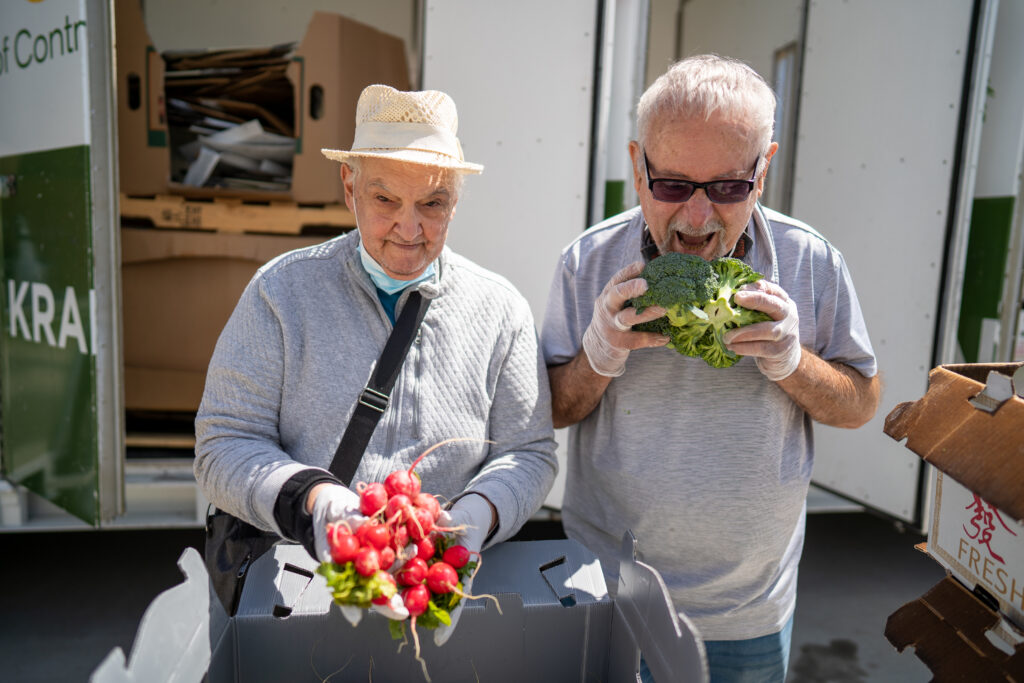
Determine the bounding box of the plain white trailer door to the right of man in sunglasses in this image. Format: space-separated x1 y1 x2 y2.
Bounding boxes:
793 0 996 524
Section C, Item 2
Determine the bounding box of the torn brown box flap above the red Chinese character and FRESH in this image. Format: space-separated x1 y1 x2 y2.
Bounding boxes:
884 362 1024 520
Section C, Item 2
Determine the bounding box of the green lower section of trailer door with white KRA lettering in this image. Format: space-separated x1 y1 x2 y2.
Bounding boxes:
0 145 99 524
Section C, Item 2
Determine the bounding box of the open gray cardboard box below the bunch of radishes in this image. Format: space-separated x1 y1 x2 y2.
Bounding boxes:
91 533 707 683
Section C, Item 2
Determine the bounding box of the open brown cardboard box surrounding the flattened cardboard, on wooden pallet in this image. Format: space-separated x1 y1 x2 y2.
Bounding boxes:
117 6 411 204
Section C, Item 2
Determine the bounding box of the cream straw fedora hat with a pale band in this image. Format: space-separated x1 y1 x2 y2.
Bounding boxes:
321 85 483 173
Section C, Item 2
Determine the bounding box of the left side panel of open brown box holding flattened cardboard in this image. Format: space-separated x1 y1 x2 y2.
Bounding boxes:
115 0 171 195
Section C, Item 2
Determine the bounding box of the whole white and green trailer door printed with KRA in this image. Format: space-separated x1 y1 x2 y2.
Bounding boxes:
0 0 124 525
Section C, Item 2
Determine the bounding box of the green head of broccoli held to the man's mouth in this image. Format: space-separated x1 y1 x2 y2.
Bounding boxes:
631 252 771 368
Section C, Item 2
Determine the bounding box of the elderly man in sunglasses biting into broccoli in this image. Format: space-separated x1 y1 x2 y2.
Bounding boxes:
542 55 879 683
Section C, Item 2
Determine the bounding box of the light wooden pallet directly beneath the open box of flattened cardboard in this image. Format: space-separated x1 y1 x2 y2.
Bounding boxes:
121 195 355 234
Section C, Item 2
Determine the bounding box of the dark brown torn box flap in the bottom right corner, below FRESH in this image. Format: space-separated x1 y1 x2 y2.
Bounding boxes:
886 577 1024 683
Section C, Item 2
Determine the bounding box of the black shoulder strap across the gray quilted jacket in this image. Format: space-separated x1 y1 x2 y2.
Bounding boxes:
331 290 430 486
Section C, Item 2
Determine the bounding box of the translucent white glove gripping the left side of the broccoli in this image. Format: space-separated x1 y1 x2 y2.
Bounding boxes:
583 261 669 377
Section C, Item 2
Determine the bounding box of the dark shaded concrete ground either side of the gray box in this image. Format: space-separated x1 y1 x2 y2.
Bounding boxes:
0 512 944 683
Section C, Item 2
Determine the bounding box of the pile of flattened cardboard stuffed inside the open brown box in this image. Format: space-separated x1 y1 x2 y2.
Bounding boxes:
164 43 295 191
